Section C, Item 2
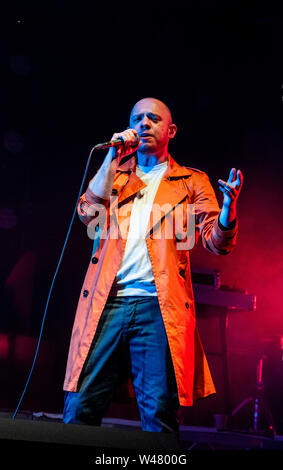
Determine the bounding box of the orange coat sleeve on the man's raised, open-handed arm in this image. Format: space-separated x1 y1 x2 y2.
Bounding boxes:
193 172 238 255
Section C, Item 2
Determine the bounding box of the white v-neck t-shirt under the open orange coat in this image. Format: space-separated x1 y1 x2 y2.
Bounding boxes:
110 161 167 297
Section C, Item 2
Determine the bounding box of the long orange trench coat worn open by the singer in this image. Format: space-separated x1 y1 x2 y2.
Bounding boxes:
64 155 238 406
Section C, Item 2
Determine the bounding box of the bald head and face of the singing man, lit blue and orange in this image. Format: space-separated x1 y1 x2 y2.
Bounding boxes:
130 98 177 154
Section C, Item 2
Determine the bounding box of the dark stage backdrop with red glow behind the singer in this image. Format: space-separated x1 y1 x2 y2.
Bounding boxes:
0 0 283 432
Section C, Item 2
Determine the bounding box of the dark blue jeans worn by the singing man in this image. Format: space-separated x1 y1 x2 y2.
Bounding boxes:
63 296 179 434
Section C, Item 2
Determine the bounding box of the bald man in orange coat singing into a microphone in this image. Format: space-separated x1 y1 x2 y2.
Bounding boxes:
63 98 243 433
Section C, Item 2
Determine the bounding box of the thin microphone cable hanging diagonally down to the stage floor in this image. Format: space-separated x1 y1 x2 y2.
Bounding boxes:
12 144 100 419
